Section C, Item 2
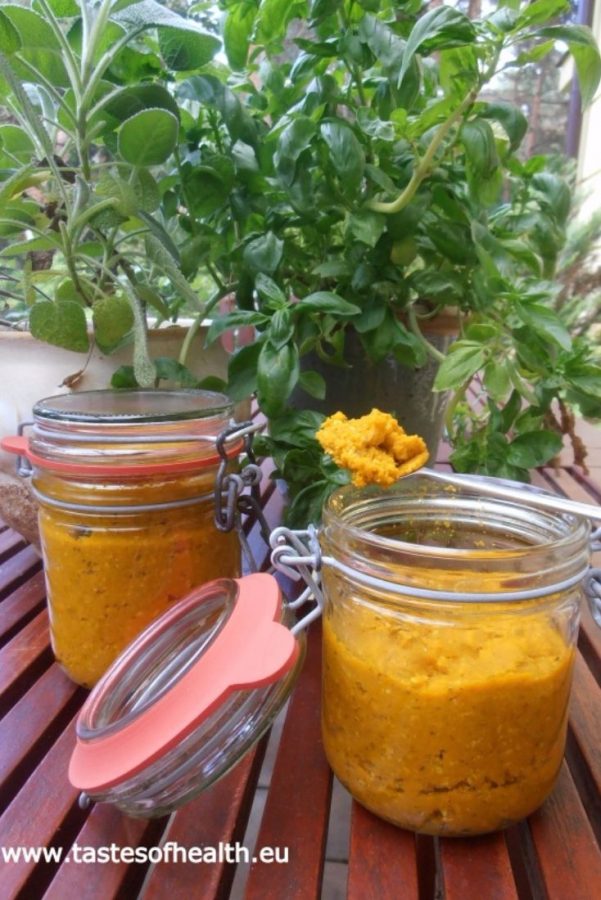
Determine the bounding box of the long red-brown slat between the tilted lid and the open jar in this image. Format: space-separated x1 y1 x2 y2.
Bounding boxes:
245 627 332 900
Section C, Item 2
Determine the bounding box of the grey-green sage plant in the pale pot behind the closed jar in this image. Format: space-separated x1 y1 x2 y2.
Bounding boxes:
0 0 229 539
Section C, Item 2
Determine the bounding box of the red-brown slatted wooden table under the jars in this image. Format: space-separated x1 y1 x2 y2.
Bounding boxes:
0 467 601 900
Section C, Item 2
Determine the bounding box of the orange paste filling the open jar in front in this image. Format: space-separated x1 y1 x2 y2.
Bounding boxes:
322 597 574 835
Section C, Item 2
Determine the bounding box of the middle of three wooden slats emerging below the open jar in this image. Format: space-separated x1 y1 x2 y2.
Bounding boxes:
440 834 519 900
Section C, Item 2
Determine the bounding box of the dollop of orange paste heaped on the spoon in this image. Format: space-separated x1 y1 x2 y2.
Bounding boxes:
316 409 428 487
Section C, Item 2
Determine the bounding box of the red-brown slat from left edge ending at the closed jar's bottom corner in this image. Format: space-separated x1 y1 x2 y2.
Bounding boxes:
0 665 83 806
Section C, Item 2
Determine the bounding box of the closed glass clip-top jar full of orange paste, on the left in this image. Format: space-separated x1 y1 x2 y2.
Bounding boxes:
28 390 240 687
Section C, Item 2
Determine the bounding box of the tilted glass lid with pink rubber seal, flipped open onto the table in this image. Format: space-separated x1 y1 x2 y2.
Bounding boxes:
69 574 302 816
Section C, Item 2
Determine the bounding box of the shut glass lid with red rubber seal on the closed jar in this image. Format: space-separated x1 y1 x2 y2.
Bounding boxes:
2 389 243 476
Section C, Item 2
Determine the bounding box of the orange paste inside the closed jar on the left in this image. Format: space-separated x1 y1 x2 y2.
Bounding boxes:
36 474 240 687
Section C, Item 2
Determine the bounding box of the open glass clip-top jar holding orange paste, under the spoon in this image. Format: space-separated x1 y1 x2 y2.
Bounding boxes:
320 476 589 835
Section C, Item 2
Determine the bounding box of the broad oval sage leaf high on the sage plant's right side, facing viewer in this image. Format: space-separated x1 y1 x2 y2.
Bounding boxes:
119 109 179 166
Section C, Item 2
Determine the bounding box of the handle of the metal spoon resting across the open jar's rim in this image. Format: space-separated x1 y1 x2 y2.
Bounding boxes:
415 469 601 522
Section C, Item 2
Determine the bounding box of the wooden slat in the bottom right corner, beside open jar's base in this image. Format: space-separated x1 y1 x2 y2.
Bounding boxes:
530 763 601 900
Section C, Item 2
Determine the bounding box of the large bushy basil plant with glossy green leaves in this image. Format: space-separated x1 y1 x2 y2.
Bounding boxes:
193 0 601 520
